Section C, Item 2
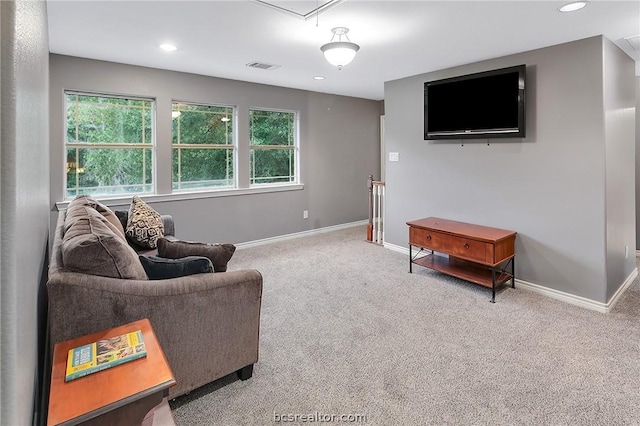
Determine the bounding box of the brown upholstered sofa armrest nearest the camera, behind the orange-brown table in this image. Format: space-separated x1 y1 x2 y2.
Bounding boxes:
47 270 262 398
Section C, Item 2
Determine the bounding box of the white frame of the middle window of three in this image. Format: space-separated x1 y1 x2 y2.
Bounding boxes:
170 99 239 194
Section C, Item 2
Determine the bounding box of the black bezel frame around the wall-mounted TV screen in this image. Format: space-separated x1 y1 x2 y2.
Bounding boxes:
424 64 527 140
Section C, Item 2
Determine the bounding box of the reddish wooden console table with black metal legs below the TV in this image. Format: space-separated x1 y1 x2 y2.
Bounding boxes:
407 217 516 303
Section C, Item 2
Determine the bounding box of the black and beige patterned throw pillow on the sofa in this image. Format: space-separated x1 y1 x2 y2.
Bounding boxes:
125 195 164 248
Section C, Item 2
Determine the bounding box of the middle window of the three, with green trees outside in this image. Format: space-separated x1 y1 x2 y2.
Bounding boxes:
172 103 235 190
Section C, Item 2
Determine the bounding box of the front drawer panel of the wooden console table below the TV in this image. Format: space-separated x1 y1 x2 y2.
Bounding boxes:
409 228 493 263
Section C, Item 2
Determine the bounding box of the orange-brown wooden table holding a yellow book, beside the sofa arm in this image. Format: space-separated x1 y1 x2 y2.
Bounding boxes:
47 319 176 425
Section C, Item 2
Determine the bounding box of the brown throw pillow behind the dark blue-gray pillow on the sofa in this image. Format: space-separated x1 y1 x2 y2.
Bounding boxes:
158 238 236 272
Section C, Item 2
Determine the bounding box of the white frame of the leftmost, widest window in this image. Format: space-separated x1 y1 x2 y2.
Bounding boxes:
62 89 157 202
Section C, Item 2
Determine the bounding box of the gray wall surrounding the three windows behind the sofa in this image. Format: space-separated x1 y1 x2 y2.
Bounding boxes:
50 55 382 243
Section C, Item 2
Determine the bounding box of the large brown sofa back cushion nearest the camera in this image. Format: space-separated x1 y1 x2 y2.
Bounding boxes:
62 205 147 280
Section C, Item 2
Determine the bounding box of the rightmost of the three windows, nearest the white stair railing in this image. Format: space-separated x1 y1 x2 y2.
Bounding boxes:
249 109 298 185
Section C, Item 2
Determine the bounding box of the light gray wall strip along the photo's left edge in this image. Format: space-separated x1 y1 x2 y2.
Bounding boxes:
0 0 49 425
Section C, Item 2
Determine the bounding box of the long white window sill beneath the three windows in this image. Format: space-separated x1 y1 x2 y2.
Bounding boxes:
56 183 304 211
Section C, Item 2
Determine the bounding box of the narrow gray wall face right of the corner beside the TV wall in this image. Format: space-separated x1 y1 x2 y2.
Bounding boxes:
603 39 636 300
